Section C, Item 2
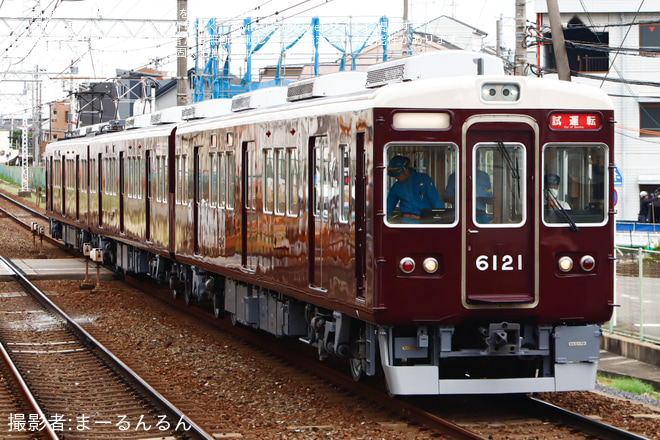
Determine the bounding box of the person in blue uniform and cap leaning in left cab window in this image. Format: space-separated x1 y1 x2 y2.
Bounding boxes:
387 156 443 223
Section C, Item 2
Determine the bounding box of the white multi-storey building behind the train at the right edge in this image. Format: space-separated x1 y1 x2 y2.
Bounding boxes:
534 0 660 221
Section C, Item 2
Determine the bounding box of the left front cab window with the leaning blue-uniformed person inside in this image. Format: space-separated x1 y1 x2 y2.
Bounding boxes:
384 143 457 227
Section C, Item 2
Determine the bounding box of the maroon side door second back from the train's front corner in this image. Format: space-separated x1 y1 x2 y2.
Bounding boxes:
308 136 331 290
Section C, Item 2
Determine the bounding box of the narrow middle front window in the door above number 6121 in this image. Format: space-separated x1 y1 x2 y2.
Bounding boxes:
471 141 527 227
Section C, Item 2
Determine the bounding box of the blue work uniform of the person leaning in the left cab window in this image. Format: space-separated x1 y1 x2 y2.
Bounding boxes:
387 169 444 223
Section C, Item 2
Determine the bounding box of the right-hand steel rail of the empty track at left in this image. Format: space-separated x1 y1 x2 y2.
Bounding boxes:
0 256 213 440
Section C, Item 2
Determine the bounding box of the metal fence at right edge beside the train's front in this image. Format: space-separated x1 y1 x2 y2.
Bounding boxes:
604 246 660 344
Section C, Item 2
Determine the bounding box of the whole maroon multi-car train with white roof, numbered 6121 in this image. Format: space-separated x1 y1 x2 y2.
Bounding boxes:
46 51 614 394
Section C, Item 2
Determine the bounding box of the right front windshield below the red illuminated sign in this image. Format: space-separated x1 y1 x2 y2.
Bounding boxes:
542 144 607 228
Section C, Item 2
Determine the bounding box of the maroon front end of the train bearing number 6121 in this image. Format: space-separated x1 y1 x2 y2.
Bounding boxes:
373 54 614 395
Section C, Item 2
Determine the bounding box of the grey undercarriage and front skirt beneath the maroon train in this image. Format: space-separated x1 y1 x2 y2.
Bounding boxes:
51 220 601 395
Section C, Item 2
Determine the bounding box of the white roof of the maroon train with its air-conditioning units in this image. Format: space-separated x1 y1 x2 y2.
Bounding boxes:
45 50 613 149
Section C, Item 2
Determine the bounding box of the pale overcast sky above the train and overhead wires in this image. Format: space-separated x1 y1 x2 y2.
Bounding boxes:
0 0 533 116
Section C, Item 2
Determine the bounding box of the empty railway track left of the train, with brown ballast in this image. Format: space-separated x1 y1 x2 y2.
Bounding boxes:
0 257 211 440
